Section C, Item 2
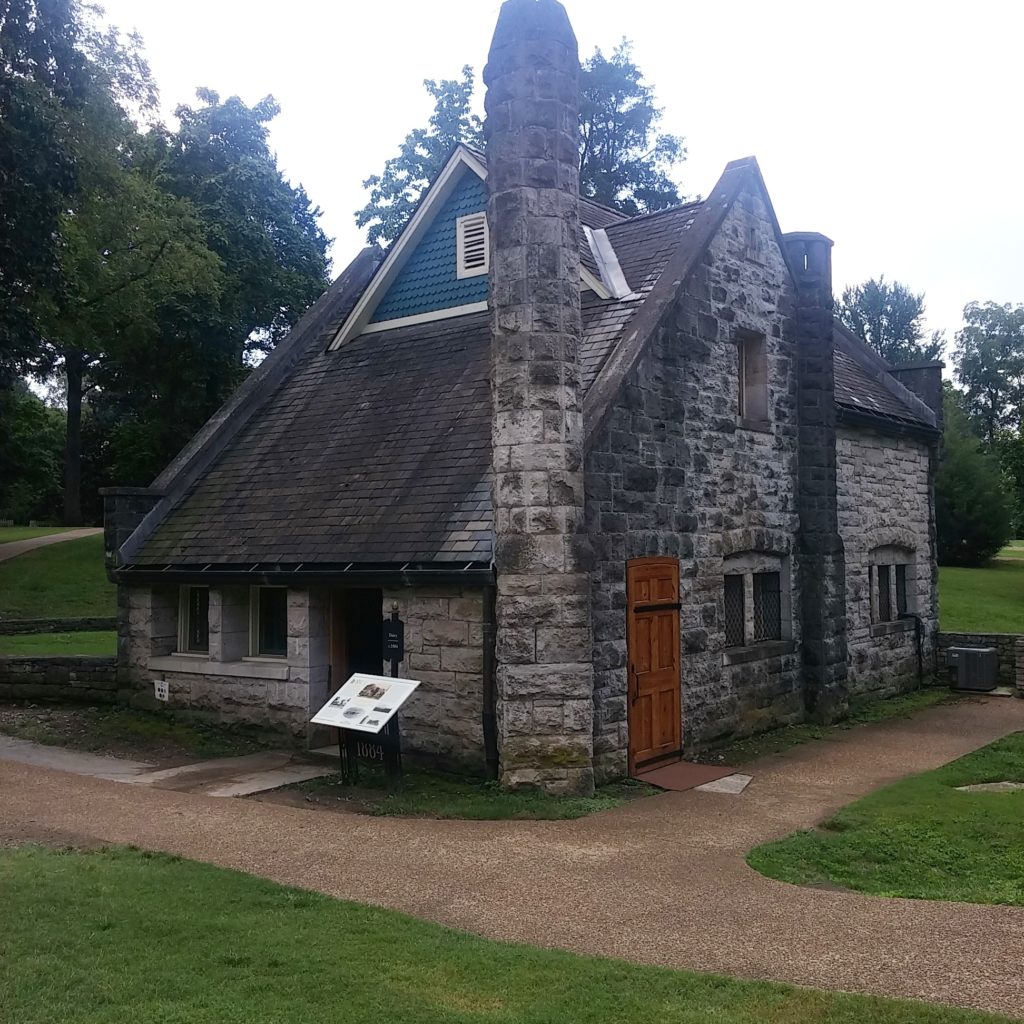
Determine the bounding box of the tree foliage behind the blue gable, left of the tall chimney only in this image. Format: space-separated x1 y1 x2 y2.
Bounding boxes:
355 65 483 245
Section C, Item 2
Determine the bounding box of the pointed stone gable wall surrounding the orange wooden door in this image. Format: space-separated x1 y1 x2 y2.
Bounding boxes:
586 186 804 778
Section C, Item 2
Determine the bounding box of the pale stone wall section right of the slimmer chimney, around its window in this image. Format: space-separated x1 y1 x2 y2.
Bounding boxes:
837 427 938 696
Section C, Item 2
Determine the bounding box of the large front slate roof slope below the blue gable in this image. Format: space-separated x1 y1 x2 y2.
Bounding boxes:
133 313 492 564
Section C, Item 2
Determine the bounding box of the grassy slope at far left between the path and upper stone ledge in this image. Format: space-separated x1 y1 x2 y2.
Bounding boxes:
0 534 117 618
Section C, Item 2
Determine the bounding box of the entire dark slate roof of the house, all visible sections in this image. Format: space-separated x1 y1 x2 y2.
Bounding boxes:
131 184 927 570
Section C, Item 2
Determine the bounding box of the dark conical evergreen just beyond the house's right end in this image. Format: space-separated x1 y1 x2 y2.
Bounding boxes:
935 386 1012 565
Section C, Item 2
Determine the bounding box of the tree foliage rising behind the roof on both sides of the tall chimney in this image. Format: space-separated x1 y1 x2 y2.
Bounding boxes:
355 46 686 244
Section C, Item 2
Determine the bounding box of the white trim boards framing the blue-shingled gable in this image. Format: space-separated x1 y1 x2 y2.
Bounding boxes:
328 145 612 352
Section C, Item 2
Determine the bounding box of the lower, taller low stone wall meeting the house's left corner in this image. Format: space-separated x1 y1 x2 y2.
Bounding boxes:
0 655 118 703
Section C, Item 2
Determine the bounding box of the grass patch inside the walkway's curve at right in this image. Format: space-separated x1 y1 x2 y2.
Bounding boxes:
746 732 1024 906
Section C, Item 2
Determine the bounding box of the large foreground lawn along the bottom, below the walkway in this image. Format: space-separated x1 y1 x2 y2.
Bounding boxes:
0 848 1007 1024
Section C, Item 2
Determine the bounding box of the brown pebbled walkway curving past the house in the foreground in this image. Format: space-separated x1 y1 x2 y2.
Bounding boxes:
0 698 1024 1016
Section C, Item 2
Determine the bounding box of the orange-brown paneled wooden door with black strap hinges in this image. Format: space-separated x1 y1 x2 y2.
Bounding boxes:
626 558 683 774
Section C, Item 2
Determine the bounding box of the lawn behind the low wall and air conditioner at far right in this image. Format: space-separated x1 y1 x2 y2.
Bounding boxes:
939 548 1024 633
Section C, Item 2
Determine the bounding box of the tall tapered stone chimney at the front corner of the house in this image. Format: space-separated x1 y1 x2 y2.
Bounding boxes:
483 0 594 793
